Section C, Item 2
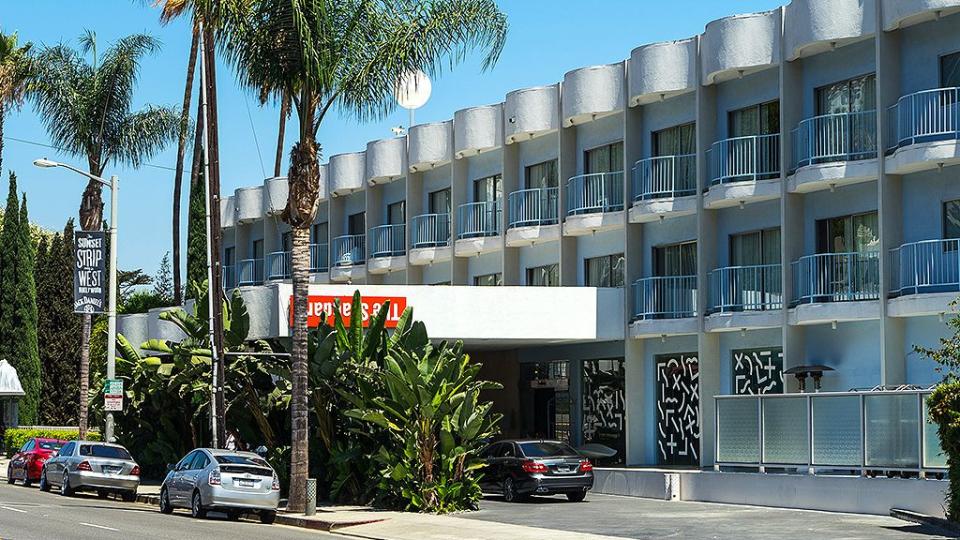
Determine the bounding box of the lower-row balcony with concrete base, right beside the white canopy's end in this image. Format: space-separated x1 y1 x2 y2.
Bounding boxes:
630 276 697 338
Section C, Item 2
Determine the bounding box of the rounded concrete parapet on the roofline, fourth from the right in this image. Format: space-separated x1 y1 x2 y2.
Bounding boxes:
629 37 697 107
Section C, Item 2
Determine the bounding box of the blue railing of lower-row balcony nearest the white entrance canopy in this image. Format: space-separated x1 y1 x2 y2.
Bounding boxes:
633 276 697 320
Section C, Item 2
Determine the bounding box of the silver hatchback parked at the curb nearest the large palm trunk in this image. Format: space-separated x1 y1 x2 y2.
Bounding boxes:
160 448 280 524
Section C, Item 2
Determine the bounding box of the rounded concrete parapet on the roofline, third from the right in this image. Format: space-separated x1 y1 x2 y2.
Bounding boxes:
700 9 780 84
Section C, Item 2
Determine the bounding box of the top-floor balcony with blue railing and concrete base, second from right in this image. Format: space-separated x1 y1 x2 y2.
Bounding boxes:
788 110 877 193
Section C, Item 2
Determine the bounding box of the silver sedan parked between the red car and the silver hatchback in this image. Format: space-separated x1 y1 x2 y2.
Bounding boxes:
40 441 140 502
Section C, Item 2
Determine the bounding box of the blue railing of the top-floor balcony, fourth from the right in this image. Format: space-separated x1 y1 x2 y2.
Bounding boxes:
633 154 697 201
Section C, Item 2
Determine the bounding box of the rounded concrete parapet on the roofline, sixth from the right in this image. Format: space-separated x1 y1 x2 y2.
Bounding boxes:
503 84 560 144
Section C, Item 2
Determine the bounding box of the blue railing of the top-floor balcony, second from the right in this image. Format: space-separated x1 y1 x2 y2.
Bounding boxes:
792 110 877 169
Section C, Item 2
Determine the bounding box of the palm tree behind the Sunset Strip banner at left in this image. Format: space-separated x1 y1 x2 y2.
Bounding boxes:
29 31 180 438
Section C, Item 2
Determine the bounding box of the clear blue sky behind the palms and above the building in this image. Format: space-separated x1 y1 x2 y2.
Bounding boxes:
0 0 784 274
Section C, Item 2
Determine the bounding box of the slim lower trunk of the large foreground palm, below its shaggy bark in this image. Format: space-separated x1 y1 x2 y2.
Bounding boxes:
287 227 310 512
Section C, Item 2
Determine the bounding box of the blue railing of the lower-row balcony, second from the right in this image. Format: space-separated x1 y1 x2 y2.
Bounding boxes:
791 251 880 304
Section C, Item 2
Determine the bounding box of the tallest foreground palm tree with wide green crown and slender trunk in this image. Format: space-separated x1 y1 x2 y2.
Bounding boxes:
224 0 507 511
